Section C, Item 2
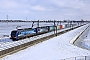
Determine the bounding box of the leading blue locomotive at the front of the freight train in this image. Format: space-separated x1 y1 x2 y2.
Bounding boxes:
11 28 36 40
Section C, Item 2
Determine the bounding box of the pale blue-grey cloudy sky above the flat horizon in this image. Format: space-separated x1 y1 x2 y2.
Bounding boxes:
0 0 90 20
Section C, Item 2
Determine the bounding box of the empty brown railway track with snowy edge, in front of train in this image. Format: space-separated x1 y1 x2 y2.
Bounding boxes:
0 25 86 58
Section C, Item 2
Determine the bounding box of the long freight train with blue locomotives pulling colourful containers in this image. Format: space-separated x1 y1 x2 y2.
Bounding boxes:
10 24 75 41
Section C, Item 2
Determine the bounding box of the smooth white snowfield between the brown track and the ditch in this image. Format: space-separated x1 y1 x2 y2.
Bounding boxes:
1 25 90 60
